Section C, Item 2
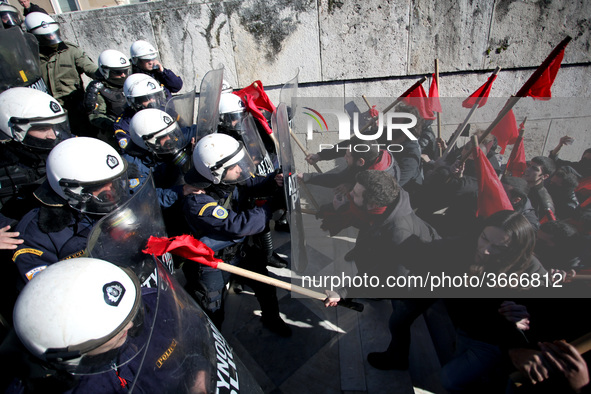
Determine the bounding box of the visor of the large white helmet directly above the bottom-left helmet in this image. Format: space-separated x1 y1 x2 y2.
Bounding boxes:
59 161 129 215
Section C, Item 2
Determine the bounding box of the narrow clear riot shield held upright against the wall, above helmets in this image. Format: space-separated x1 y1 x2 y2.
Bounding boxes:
196 68 224 141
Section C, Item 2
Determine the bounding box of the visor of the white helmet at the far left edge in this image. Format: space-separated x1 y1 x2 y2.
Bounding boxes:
10 113 72 150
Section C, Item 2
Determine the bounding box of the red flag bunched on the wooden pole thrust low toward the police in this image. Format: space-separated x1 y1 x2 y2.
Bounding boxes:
142 235 223 268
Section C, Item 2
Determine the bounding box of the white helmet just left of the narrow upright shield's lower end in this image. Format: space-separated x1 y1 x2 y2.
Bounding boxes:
129 108 187 154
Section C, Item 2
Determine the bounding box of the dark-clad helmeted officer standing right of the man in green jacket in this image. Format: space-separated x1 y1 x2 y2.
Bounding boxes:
84 49 131 148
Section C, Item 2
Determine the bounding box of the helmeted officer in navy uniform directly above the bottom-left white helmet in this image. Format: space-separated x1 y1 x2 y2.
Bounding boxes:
12 137 129 283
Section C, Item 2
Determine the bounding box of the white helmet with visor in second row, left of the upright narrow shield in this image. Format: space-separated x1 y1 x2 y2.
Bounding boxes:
123 73 166 111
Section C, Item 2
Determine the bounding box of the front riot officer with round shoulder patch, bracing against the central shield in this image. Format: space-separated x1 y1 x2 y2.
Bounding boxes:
183 134 291 336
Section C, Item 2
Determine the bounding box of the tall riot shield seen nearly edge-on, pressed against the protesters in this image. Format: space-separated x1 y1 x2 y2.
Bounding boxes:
271 103 308 273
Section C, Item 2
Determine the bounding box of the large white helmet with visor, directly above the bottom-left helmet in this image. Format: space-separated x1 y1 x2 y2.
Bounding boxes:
46 137 129 215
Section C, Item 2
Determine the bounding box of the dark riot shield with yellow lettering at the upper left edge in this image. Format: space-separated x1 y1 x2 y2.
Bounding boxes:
0 28 47 93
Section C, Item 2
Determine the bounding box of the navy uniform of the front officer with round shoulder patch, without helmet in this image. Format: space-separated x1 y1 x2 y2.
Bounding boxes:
183 173 291 336
